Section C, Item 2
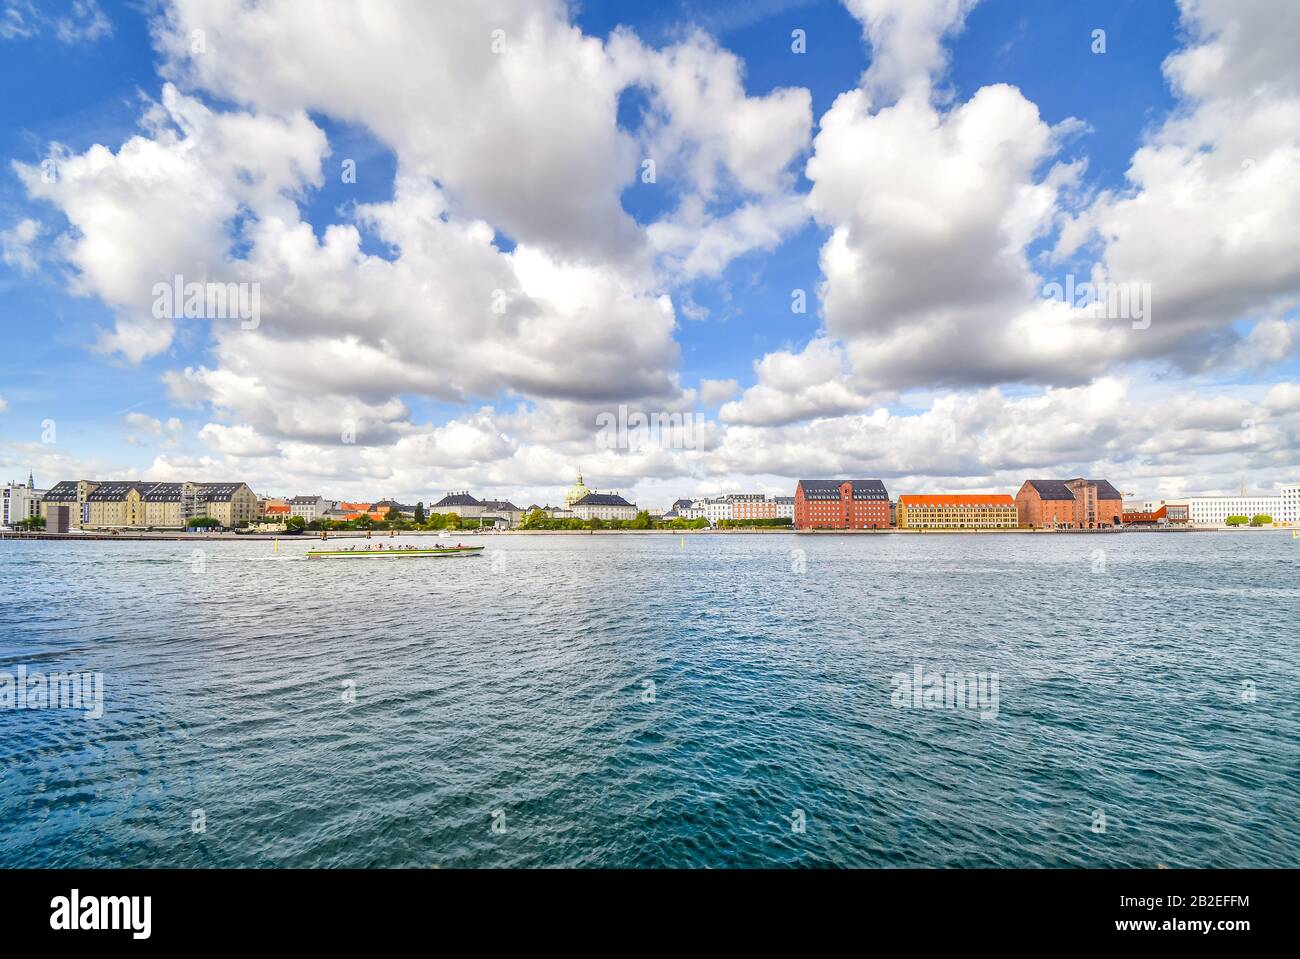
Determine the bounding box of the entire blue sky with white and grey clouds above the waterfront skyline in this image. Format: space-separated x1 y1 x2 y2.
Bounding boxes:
0 0 1300 507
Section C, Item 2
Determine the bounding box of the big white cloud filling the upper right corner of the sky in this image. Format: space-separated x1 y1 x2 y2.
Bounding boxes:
1058 0 1300 369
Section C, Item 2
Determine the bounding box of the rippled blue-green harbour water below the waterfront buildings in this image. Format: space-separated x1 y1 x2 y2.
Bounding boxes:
0 533 1300 867
